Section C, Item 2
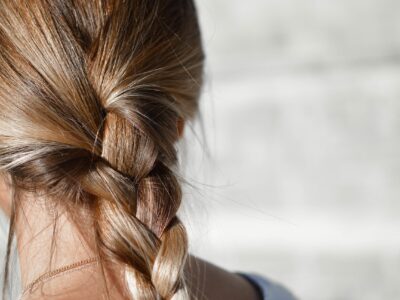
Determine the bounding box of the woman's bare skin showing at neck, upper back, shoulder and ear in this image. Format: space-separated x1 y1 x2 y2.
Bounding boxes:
0 121 260 300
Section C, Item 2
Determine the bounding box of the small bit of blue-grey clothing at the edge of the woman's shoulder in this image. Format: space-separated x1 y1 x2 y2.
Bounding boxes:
237 272 297 300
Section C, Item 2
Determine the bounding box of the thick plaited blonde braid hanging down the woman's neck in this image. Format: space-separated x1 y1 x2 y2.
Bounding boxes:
83 101 187 299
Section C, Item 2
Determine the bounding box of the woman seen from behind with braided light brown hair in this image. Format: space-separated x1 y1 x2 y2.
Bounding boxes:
0 0 291 300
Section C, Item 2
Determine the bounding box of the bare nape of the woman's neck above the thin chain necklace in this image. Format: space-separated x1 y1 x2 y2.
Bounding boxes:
15 193 96 287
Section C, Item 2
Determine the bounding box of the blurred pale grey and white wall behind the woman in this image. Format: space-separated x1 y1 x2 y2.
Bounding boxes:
0 0 400 300
